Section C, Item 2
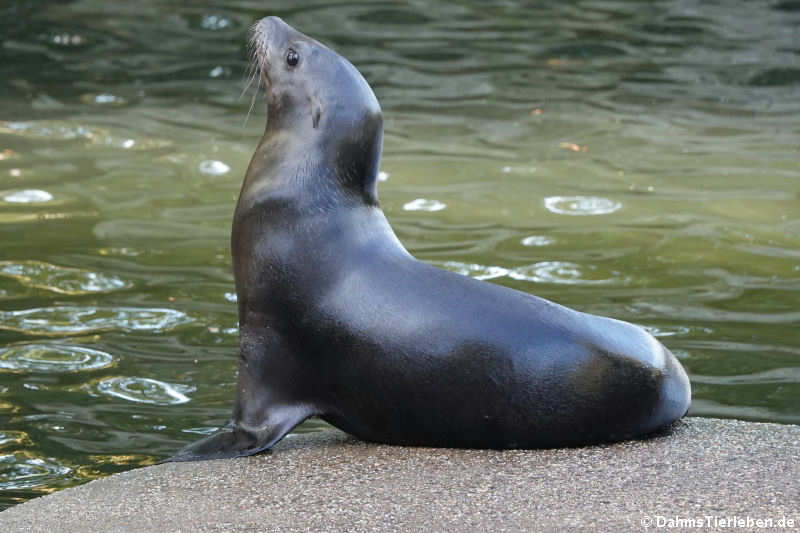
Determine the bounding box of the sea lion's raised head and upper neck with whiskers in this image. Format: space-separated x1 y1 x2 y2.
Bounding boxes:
248 17 383 204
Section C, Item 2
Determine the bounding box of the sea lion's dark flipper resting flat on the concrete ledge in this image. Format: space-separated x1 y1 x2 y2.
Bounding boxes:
160 409 311 463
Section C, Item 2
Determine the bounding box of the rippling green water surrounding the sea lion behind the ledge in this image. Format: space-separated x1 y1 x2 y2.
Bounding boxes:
0 0 800 508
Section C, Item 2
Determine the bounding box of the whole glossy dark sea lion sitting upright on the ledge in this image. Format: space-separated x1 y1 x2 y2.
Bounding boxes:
170 17 690 461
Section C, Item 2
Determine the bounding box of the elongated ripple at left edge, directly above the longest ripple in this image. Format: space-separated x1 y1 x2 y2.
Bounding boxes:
0 261 131 295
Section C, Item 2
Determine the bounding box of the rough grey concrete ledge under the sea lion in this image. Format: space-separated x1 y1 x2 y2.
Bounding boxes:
0 418 800 533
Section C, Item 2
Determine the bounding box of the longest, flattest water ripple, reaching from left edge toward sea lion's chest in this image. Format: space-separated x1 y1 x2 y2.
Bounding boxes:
0 306 192 335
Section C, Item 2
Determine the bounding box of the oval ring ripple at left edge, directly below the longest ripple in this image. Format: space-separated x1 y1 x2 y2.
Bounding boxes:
0 344 114 373
